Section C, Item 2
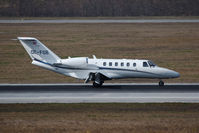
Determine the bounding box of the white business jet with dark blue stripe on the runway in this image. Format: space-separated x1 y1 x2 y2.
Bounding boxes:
18 37 180 87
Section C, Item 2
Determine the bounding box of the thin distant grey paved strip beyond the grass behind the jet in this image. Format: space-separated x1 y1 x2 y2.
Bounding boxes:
0 19 199 23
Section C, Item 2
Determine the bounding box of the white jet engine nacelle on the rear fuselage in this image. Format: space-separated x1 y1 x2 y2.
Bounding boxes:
61 57 88 68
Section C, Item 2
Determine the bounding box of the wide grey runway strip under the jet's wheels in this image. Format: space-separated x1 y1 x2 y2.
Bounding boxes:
0 83 199 103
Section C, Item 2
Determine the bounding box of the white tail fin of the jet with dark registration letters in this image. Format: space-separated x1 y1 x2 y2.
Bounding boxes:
18 37 60 64
